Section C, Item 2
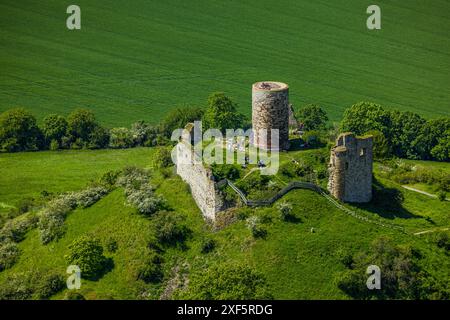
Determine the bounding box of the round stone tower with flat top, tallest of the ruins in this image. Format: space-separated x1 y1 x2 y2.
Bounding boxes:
252 81 289 150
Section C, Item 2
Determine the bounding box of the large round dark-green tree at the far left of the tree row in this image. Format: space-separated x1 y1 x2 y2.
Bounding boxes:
0 108 43 152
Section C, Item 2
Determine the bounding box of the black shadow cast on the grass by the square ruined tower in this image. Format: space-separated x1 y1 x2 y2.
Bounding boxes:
352 178 422 223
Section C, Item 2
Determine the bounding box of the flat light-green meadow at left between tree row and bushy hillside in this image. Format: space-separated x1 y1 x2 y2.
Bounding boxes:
0 148 154 211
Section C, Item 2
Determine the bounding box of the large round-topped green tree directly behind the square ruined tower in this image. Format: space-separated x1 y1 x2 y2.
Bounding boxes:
341 102 391 140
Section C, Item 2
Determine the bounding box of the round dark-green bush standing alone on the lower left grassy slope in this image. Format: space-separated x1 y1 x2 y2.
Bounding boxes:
65 236 107 280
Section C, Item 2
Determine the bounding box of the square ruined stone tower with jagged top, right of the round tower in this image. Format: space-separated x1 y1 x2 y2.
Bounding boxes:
328 133 373 203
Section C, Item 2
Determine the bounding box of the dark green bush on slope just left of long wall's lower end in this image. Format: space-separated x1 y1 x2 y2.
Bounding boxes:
153 211 191 246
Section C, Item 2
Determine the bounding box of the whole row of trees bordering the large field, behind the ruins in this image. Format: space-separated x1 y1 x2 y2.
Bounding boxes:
0 93 450 161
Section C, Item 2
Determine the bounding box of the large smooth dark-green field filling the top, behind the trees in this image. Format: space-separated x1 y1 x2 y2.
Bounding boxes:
0 0 450 126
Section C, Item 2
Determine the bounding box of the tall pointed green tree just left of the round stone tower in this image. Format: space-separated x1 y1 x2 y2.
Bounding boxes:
202 92 245 133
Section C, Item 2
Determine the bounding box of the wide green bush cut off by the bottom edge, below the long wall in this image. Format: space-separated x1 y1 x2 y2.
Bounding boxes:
175 264 273 300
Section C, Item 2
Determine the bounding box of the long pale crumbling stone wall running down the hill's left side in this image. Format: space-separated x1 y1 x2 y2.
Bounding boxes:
176 141 226 221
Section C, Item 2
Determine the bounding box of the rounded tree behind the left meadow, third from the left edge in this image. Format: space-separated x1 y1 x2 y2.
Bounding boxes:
67 109 99 145
